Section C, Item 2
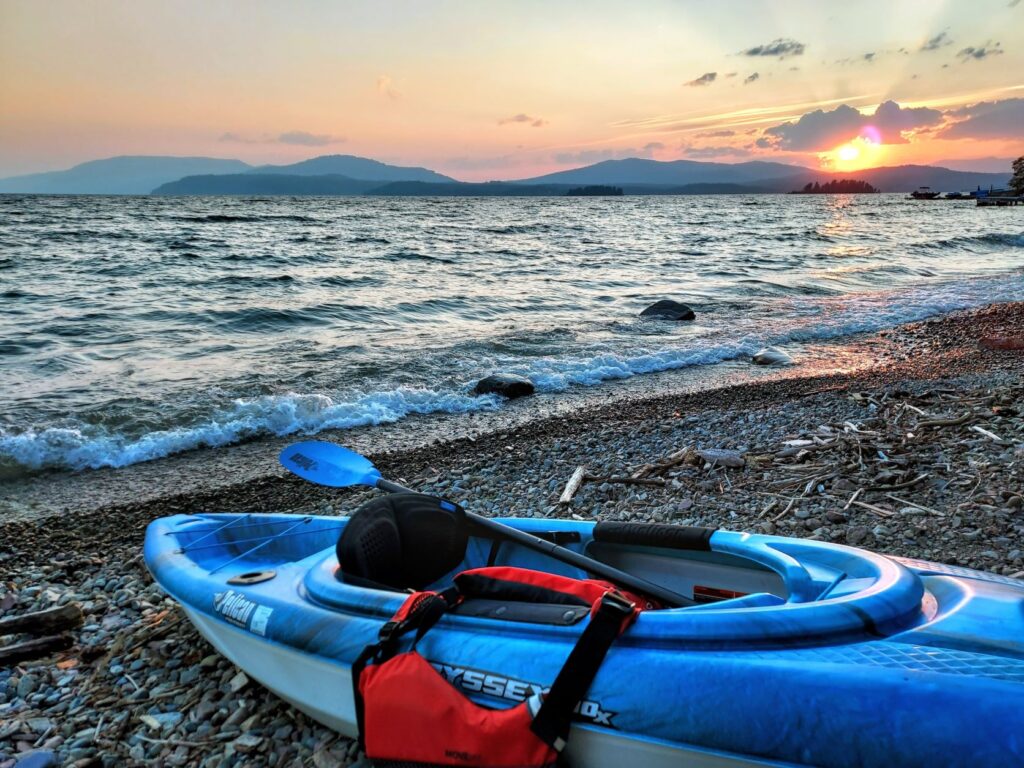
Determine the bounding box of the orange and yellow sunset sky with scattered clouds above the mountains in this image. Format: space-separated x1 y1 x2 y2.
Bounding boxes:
0 0 1024 180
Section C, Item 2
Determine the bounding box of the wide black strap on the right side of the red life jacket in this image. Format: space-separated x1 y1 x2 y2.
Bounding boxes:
529 592 634 752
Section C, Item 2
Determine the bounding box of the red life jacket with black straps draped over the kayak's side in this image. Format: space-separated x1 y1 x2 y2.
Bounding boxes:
352 567 645 768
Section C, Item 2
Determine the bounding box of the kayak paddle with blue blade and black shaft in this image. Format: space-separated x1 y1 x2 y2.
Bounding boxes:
280 440 695 607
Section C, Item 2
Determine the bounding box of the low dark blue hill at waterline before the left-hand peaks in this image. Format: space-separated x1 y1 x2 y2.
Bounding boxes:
153 173 381 196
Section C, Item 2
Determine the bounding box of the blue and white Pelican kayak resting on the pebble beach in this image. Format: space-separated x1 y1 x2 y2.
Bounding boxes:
145 514 1024 768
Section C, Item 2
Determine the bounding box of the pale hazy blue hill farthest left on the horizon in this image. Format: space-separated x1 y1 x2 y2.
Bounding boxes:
0 156 250 195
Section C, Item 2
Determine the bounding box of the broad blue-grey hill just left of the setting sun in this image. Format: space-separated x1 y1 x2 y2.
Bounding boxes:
513 158 809 187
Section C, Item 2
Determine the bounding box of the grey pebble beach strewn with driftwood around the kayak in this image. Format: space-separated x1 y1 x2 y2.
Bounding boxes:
0 303 1024 768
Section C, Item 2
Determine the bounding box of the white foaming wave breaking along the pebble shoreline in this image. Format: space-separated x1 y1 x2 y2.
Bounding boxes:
0 274 1024 469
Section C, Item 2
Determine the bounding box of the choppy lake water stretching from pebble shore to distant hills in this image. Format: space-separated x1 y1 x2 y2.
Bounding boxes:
0 195 1024 476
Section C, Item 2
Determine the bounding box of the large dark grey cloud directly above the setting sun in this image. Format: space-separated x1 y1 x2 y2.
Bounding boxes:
758 101 942 152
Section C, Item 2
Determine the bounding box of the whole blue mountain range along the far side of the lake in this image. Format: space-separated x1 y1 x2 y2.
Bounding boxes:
0 155 1010 196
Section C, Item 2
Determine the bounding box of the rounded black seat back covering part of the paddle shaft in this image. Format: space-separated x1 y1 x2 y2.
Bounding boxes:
337 494 469 590
